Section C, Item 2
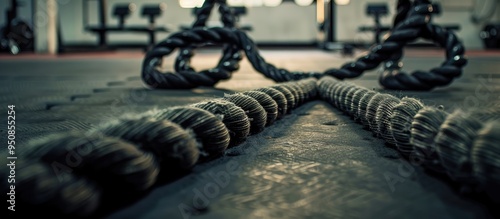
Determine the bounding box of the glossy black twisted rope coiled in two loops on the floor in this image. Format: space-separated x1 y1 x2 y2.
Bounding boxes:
142 0 467 90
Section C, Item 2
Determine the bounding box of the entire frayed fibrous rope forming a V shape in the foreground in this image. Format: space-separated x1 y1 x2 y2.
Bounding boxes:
5 77 500 216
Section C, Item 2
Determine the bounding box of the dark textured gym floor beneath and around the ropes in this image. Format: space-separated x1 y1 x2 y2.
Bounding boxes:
0 49 500 219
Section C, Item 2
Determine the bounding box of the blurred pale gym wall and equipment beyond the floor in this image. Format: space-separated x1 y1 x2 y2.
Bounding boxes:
0 0 500 54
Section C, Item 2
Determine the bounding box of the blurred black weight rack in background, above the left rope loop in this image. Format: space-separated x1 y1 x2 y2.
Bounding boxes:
83 0 170 50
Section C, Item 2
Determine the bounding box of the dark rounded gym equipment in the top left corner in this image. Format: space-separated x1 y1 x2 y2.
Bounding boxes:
0 0 34 55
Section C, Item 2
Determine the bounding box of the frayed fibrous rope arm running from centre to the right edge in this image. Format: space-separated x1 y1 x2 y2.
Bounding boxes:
317 77 500 203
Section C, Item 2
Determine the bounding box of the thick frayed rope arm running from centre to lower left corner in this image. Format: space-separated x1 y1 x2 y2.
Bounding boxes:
0 79 317 217
